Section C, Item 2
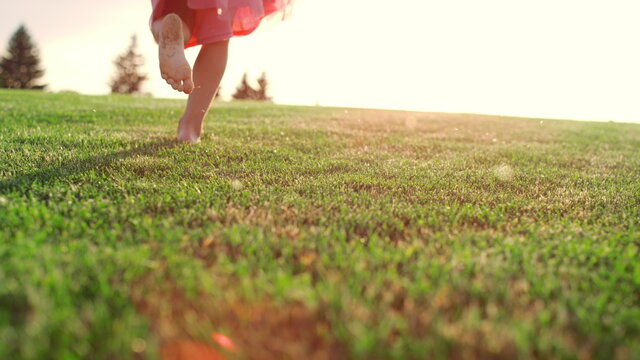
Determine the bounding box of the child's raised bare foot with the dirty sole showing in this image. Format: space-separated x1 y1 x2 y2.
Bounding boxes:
158 14 193 94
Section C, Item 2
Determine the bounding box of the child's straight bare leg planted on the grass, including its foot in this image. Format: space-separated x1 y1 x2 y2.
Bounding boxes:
178 40 229 142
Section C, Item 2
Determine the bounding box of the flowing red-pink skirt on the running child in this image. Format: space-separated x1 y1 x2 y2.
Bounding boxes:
151 0 292 48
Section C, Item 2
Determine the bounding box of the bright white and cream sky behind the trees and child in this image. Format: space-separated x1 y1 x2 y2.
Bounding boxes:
0 0 640 122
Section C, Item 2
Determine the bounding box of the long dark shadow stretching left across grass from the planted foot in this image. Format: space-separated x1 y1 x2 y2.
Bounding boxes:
0 140 179 194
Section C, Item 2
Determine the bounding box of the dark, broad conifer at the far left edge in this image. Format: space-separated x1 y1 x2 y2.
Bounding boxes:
0 25 46 90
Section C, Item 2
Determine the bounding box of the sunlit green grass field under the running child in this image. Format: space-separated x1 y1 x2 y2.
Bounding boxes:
0 91 640 359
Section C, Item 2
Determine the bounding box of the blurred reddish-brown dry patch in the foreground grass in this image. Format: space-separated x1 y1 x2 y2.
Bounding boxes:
131 275 346 360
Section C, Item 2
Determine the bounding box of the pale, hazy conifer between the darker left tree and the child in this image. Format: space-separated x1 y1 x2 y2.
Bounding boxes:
109 35 147 94
